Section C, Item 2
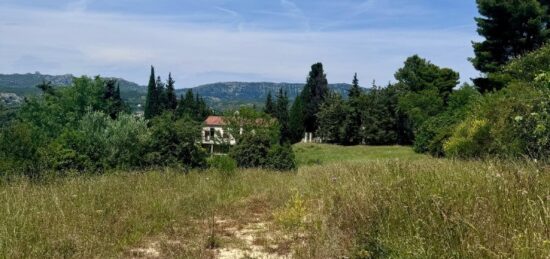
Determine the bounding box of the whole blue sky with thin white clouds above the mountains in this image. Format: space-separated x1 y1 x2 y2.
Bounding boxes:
0 0 480 88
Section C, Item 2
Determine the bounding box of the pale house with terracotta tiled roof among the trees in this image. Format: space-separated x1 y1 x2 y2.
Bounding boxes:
201 116 237 154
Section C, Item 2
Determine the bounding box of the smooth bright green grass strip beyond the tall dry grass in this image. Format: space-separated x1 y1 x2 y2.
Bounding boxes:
294 143 425 166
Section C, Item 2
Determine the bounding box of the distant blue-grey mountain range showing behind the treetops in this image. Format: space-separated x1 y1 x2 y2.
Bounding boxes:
0 72 358 110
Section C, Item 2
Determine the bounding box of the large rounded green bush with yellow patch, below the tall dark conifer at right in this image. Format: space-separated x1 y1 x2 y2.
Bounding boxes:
445 83 550 159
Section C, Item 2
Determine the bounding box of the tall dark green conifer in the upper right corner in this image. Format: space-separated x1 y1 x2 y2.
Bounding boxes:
470 0 550 92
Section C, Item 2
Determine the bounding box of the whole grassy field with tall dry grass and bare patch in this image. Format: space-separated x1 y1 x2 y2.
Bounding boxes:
0 144 550 258
